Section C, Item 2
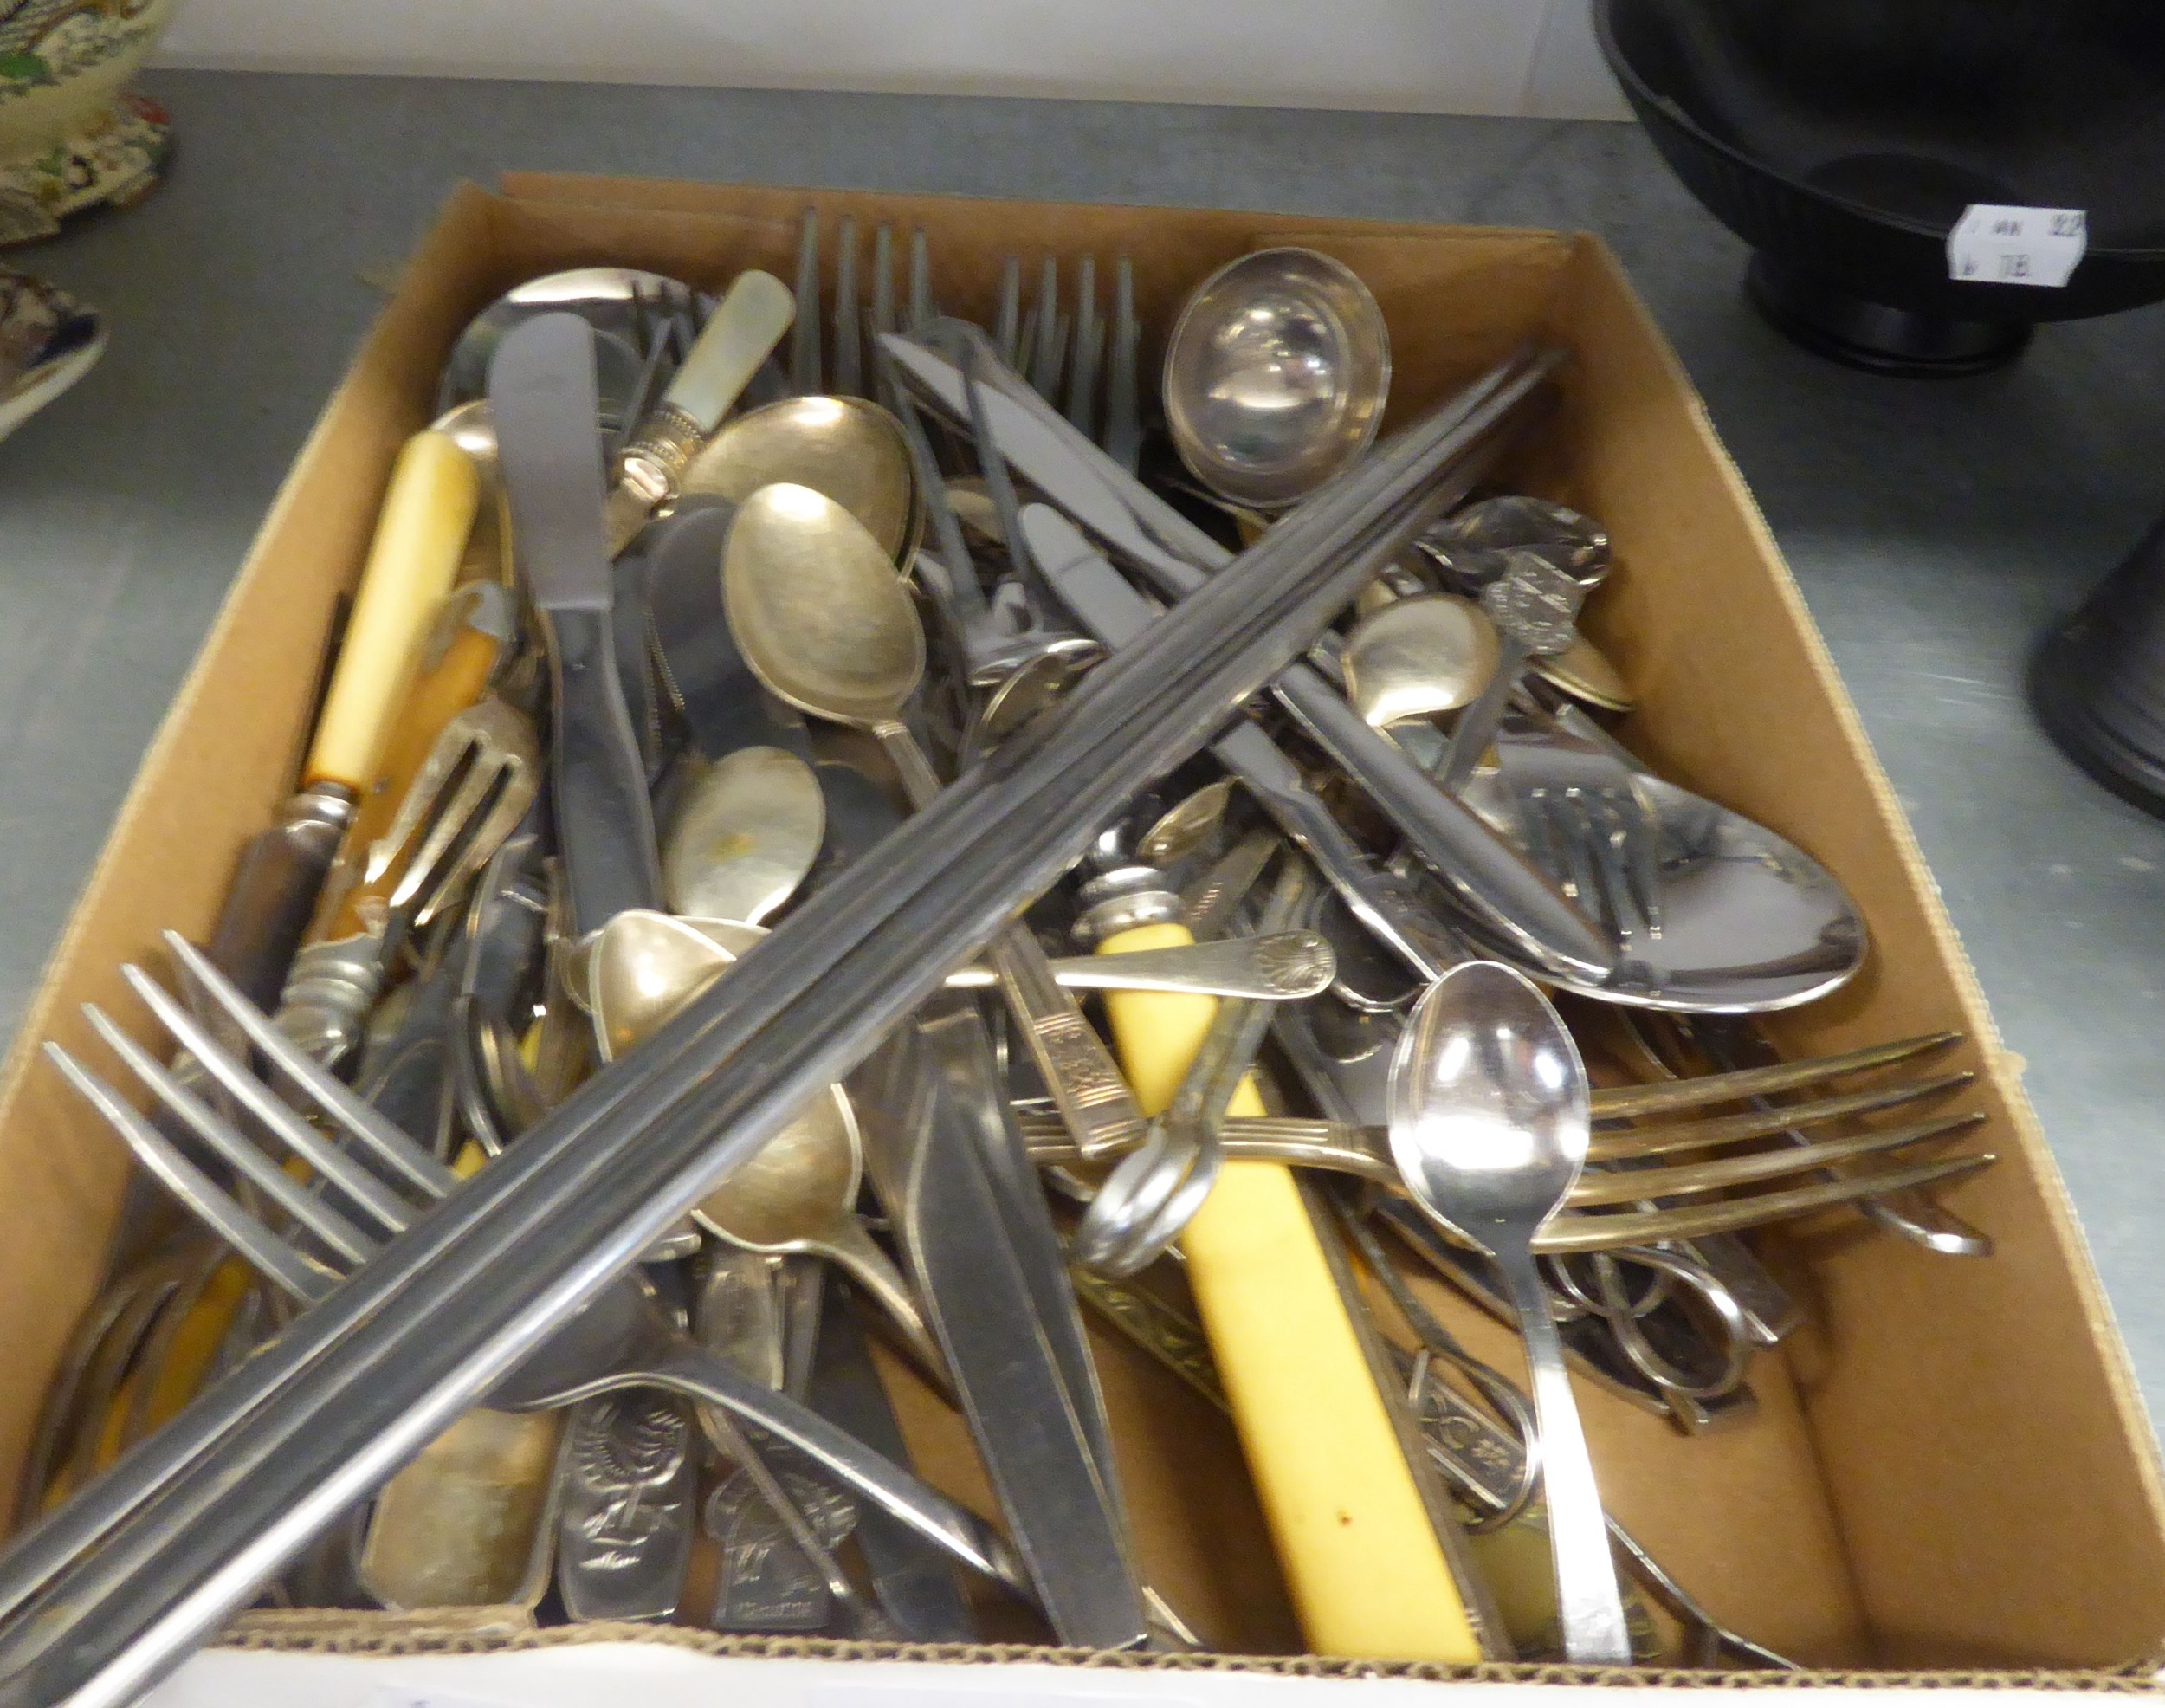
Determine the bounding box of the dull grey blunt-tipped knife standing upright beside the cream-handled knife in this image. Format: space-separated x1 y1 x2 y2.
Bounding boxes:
489 314 662 937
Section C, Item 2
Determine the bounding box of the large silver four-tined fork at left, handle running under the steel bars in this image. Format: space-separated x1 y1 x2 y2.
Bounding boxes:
46 931 1035 1602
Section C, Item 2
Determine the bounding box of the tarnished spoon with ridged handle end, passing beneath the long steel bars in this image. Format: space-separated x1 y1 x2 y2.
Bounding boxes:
721 482 1143 1156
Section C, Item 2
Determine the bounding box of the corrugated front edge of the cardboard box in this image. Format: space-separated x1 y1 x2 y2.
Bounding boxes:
206 1613 2159 1695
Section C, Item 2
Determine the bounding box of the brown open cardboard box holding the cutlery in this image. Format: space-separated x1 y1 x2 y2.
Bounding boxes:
0 178 2165 1682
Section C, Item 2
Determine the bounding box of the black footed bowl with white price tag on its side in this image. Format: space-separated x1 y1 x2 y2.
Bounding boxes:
1596 0 2165 374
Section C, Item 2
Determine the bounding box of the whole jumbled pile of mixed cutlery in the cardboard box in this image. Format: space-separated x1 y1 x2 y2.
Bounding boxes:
0 210 1994 1699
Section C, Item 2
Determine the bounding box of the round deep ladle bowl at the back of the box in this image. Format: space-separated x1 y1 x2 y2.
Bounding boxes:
1165 249 1390 511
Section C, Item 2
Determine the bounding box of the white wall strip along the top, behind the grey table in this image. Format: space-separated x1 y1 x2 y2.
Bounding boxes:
160 0 1626 119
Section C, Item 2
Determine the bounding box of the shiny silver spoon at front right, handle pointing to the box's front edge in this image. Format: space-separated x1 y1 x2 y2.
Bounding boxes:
1390 961 1631 1667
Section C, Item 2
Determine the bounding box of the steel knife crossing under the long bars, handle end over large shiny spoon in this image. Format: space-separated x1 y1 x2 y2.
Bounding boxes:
882 329 1618 980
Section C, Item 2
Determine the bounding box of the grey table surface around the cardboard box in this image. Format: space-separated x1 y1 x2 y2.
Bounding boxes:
12 71 2165 1416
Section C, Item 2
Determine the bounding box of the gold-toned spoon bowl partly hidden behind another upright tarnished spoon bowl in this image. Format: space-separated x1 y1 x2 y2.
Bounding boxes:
680 396 922 565
